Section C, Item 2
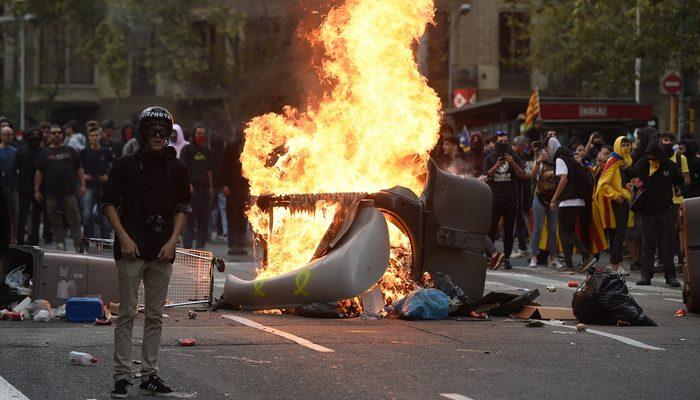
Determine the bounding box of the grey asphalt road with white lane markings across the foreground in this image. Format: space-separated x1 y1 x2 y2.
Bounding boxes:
0 241 700 400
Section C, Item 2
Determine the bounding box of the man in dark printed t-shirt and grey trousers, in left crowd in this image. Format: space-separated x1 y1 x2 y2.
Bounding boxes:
34 125 85 251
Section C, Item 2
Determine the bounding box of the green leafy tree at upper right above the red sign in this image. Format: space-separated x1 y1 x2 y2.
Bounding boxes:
509 0 700 95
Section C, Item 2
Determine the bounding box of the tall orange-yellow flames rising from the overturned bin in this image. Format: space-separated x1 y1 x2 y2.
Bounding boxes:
241 0 441 300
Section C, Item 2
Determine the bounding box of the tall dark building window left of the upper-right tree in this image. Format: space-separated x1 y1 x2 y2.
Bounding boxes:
498 12 530 90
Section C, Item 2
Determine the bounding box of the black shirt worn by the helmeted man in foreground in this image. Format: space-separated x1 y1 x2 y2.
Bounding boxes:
102 147 190 262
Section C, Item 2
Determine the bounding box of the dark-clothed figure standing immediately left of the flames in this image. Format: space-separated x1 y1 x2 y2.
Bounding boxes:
221 140 250 255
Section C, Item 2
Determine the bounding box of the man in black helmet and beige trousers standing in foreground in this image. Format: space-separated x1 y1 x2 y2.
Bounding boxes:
102 107 190 398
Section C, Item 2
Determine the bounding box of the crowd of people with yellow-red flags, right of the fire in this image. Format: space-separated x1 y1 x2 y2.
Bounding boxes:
433 121 700 287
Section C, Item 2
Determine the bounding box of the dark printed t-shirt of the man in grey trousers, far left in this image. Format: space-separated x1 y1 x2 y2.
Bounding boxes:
38 145 82 197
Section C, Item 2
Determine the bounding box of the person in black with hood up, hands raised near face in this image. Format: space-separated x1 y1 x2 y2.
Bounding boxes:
628 140 683 287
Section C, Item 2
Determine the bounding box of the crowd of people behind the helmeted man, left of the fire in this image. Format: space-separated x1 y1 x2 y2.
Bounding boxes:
0 117 249 255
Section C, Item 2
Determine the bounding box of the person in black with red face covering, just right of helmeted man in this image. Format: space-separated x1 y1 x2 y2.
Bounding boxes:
180 124 214 249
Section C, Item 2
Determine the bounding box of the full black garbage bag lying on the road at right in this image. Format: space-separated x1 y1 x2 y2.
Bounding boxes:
571 272 656 326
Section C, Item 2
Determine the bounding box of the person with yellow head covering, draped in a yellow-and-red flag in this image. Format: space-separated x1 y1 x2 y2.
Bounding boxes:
594 136 632 275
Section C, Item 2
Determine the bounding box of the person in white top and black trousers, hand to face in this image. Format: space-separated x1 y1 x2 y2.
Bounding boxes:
547 138 596 273
